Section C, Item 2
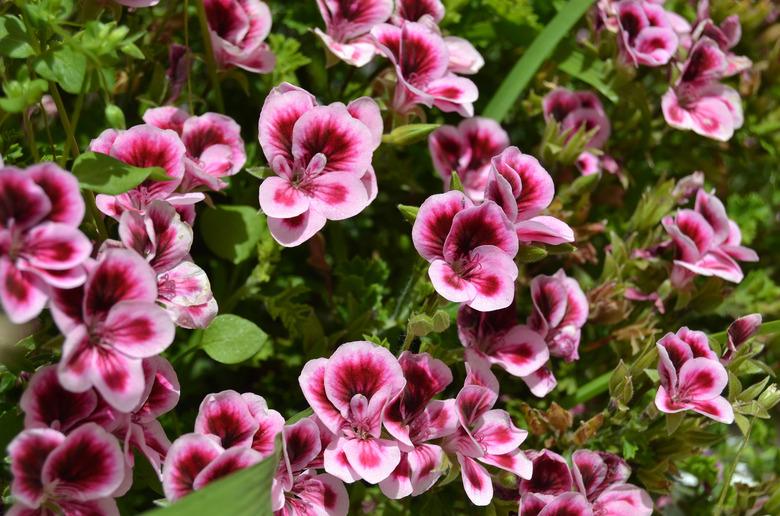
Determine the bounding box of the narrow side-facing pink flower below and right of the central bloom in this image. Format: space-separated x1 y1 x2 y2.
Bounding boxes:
528 269 588 362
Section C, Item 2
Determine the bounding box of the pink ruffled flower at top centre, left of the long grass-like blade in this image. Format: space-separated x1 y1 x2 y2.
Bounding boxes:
371 21 479 116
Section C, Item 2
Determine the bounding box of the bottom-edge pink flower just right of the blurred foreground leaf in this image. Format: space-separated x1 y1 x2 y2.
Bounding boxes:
271 416 349 516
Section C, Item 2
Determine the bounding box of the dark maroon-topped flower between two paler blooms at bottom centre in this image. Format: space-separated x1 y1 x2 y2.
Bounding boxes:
379 351 458 499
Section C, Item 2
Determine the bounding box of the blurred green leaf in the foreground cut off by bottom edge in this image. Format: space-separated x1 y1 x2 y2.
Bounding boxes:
145 439 281 516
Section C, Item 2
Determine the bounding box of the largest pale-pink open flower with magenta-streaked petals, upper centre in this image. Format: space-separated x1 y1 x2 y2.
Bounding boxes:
259 83 382 246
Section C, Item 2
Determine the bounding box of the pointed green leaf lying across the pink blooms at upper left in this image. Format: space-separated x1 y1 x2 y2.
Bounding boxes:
73 152 169 195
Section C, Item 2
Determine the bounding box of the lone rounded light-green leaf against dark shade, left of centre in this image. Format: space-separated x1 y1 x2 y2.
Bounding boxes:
201 314 268 364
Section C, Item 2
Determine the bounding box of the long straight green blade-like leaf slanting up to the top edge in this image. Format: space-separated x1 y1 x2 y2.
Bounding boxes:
484 0 594 122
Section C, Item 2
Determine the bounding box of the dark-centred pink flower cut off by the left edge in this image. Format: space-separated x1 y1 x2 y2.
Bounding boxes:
0 163 92 324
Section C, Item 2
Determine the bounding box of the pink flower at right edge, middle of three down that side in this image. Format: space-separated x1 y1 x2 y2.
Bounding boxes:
662 189 758 288
